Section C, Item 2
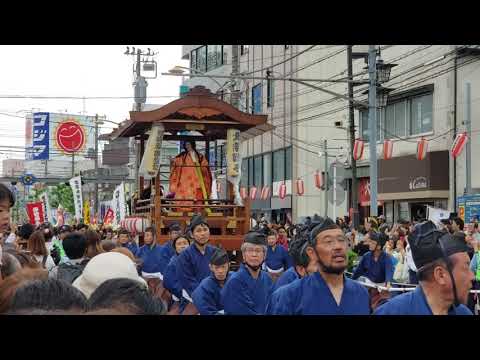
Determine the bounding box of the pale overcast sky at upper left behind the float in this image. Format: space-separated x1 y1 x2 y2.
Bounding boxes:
0 45 188 167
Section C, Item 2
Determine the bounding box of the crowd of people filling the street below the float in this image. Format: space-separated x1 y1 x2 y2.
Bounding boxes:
0 184 480 315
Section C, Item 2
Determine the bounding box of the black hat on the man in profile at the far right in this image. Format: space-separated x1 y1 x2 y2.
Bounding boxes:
408 221 469 268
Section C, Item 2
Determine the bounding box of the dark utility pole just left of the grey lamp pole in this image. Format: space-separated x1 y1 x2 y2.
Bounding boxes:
347 45 360 229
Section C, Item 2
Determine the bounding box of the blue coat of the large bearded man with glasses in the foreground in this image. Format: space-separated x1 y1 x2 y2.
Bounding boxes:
268 272 370 315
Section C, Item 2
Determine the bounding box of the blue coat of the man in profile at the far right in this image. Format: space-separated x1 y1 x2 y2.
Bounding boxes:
374 286 473 315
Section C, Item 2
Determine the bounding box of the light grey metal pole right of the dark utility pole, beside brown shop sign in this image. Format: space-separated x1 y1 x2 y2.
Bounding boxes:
368 45 378 216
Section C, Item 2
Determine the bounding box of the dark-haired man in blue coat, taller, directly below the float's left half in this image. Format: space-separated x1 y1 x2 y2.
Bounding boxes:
177 215 215 310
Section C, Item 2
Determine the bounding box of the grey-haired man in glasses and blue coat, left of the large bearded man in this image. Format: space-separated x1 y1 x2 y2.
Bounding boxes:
221 232 273 315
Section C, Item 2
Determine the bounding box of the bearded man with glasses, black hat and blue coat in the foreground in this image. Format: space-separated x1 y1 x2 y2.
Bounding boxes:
268 218 370 315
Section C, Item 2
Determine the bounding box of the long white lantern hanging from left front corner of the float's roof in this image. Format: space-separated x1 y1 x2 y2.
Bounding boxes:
138 124 165 180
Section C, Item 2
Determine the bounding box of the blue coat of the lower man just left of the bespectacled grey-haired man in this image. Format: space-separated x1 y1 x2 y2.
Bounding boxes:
192 272 233 315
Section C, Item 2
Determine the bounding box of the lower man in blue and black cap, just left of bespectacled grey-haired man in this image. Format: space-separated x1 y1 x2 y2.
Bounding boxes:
192 249 233 315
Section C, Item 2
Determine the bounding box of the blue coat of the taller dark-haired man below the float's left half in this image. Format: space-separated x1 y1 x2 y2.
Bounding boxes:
177 243 215 301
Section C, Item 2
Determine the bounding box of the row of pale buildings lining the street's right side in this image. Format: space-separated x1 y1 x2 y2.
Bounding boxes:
179 45 480 222
